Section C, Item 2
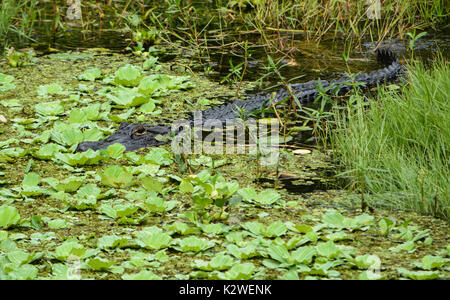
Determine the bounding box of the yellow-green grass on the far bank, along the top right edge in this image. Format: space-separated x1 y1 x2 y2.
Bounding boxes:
228 0 449 40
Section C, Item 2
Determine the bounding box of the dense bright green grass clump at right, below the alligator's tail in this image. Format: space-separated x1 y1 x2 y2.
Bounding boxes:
331 58 450 219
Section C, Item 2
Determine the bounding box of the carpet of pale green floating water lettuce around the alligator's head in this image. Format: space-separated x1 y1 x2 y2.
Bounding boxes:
0 44 450 280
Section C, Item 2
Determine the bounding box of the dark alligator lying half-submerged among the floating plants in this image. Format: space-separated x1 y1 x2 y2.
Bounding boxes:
76 49 403 152
